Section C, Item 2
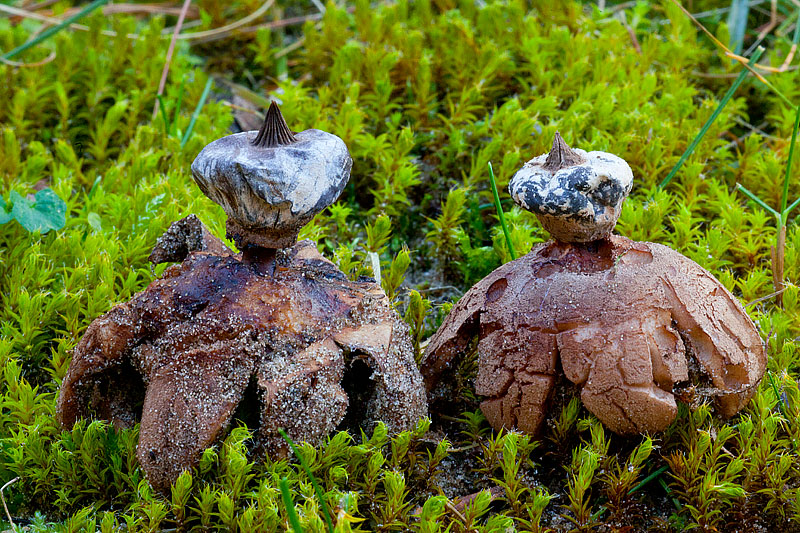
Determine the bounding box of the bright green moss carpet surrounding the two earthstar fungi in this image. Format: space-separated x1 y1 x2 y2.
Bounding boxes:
0 0 800 532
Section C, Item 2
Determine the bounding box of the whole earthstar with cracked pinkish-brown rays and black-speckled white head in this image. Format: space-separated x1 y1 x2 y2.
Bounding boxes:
422 134 766 434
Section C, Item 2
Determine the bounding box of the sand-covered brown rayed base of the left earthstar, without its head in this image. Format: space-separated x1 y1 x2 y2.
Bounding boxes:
57 233 427 490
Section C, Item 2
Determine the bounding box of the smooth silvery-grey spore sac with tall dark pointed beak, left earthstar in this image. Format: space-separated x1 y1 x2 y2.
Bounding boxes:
192 102 353 250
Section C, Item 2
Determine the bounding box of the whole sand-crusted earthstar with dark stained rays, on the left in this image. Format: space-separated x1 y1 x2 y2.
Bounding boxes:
57 100 427 490
